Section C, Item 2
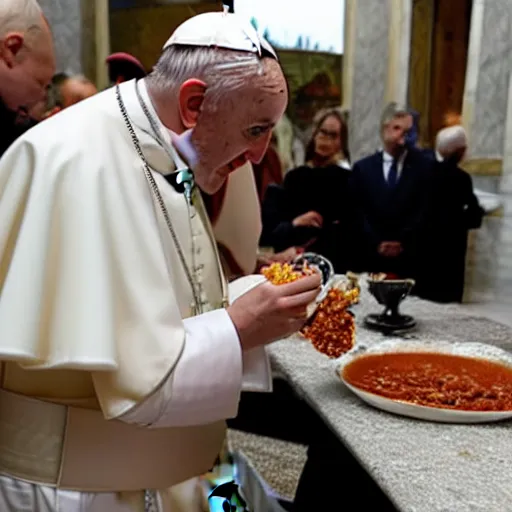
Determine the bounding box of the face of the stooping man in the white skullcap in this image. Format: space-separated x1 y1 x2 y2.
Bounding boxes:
192 59 288 194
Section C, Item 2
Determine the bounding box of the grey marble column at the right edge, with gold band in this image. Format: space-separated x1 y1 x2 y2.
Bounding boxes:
463 0 512 302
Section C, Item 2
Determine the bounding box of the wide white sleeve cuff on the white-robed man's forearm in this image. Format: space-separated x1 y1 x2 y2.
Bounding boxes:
118 309 271 428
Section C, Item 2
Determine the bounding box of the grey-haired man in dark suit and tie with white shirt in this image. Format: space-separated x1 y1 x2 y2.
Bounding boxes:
351 102 432 277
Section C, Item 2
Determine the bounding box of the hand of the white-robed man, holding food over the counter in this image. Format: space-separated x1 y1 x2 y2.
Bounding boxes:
227 274 321 350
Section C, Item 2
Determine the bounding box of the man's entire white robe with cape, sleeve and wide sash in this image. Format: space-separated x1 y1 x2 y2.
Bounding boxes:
0 81 271 512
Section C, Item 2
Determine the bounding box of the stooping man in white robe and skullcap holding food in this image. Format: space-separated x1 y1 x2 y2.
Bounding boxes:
0 8 320 512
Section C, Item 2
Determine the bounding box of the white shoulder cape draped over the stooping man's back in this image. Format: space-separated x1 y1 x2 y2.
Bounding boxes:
0 82 220 417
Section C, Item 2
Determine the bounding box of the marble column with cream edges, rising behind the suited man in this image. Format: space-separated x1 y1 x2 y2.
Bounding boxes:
343 0 412 160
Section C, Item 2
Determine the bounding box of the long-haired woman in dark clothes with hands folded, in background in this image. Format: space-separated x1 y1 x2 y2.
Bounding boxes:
261 109 350 271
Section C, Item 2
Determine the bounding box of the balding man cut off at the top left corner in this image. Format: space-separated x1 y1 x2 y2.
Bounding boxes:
0 0 55 156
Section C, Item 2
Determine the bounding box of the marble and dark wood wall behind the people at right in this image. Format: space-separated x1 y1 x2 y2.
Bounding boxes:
343 0 512 303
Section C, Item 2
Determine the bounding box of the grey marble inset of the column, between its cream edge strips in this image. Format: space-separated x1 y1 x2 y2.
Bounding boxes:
348 0 391 160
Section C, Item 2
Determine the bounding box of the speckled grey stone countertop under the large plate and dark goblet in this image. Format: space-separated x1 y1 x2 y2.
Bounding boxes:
269 285 512 512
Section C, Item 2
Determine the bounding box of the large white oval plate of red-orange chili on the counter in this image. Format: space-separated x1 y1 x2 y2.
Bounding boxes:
337 340 512 423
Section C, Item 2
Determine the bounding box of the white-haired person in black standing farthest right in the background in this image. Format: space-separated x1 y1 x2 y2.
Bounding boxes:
417 125 484 302
